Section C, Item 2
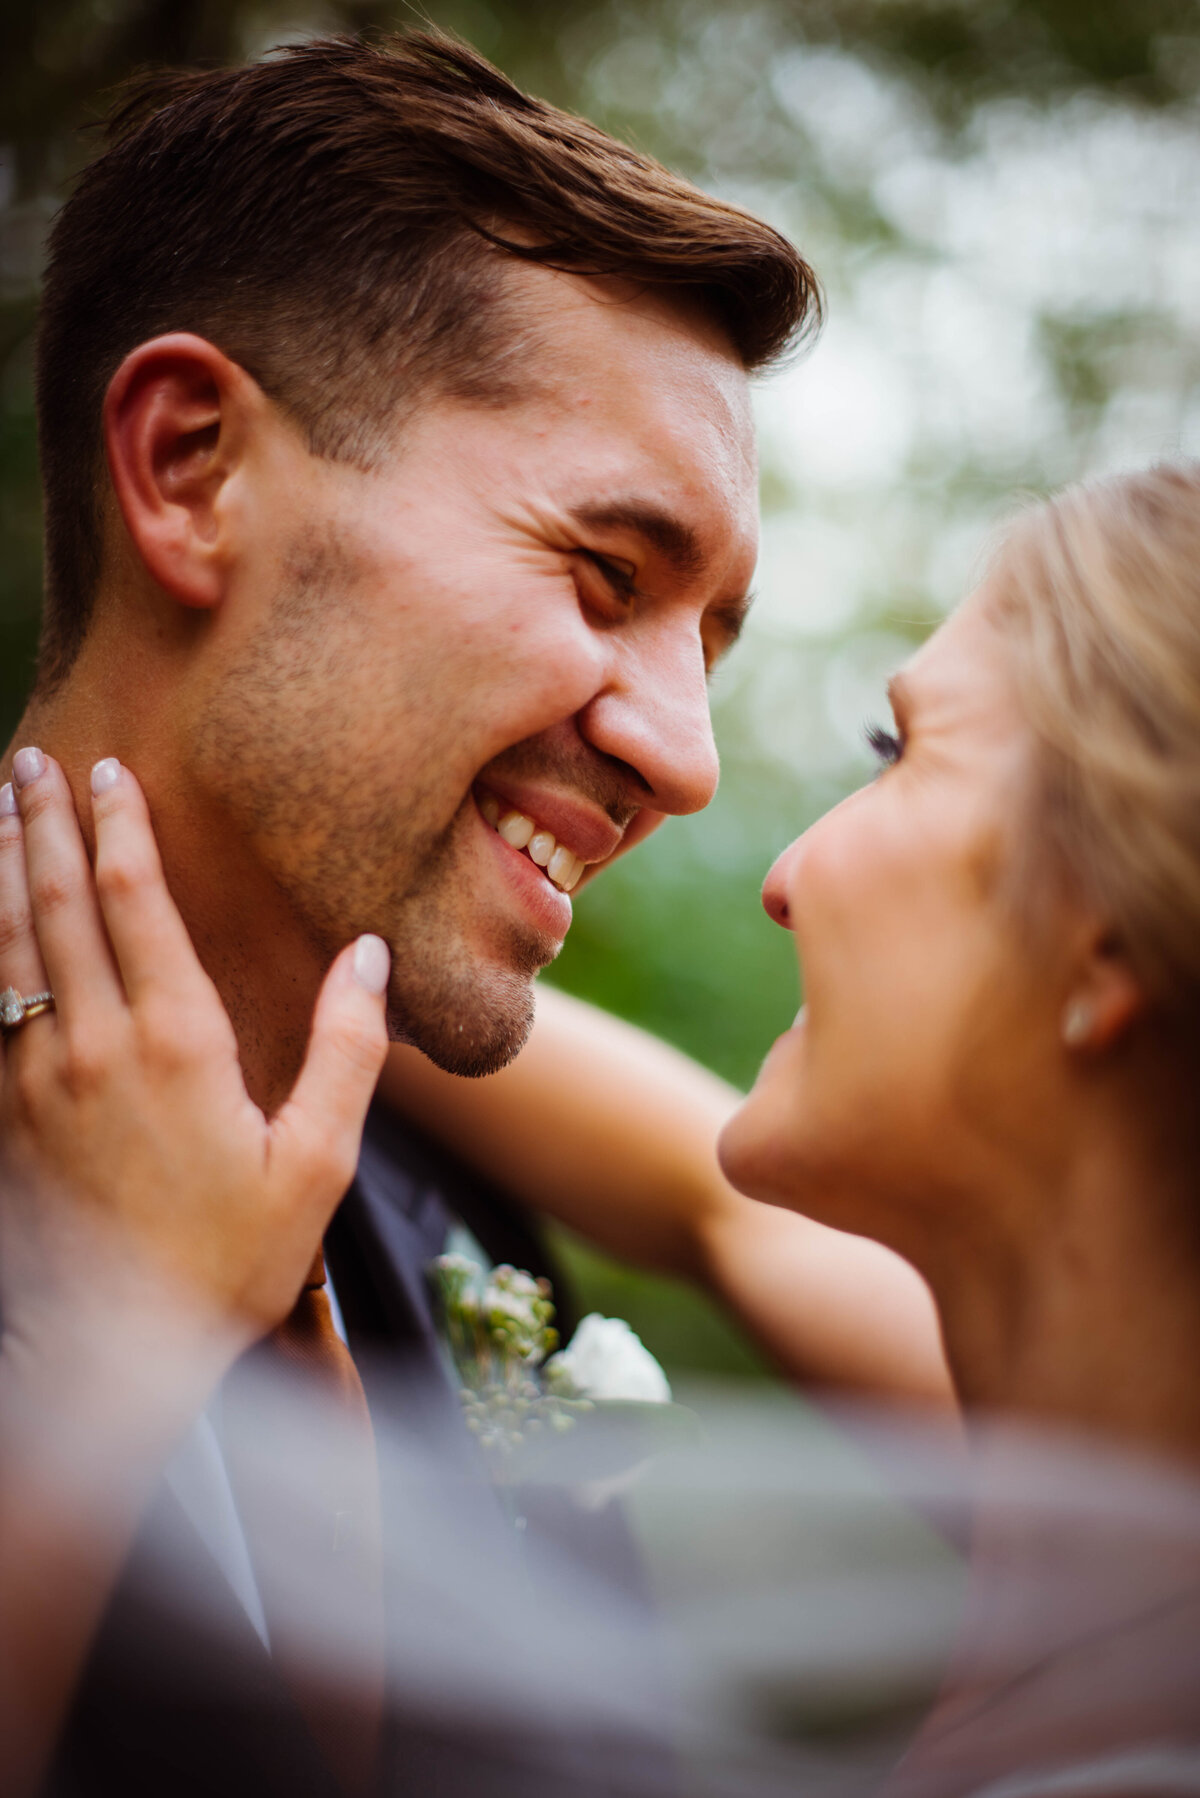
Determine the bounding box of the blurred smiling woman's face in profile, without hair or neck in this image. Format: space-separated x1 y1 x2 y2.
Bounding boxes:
721 593 1065 1266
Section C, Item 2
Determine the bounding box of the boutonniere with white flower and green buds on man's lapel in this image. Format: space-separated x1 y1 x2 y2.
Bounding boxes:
428 1255 696 1482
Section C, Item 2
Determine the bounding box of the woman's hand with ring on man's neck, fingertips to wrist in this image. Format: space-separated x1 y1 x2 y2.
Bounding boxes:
0 750 389 1359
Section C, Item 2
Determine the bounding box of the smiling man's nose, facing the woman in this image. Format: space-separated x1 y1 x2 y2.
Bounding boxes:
579 640 720 813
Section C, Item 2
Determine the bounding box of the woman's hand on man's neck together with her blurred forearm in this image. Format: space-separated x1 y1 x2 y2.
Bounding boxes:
0 750 389 1798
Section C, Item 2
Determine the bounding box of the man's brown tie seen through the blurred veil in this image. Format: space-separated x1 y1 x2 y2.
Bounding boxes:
221 1253 383 1798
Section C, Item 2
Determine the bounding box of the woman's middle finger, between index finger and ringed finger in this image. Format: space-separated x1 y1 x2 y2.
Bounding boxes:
13 748 124 1019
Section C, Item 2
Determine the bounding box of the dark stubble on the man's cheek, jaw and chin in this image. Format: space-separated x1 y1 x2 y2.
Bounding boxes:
191 527 547 1077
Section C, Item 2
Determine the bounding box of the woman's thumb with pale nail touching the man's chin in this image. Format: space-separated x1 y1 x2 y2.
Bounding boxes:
272 937 392 1197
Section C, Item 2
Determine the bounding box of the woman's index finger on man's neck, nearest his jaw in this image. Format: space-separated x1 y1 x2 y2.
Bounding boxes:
92 757 214 1005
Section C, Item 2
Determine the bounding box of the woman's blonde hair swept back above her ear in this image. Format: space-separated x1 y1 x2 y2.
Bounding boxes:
991 462 1200 1009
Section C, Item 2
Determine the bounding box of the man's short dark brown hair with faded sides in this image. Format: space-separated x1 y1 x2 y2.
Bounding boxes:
38 31 820 690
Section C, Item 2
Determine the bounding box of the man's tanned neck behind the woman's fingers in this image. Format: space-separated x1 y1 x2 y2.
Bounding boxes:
7 656 324 1113
